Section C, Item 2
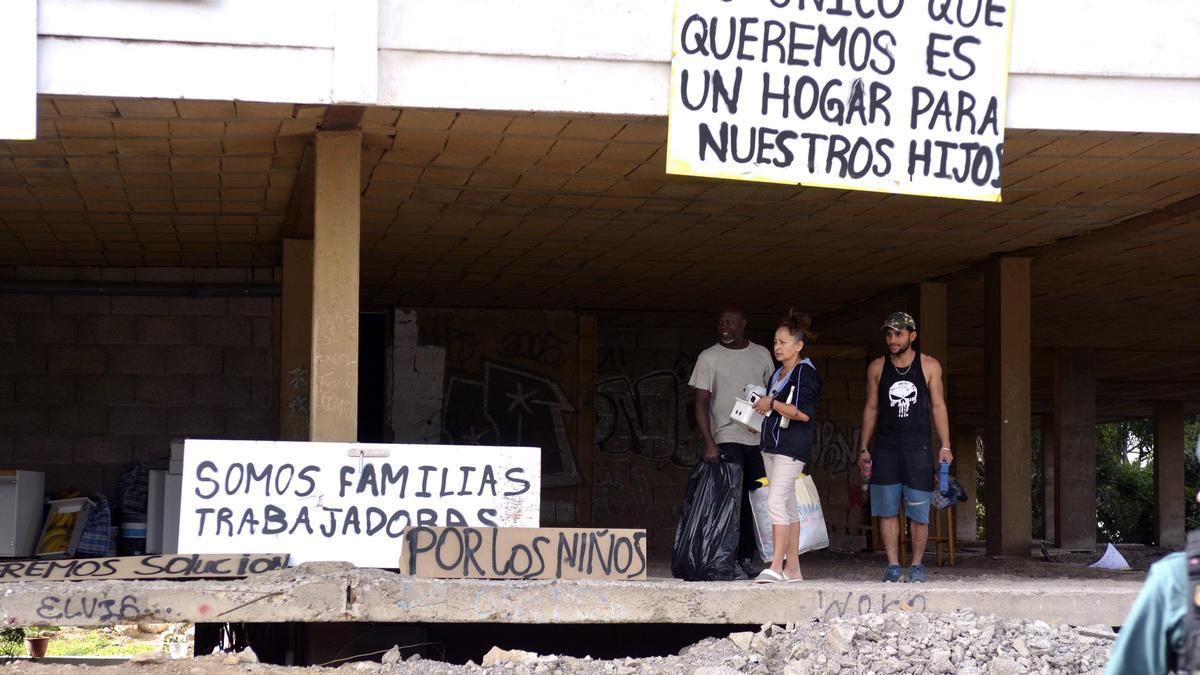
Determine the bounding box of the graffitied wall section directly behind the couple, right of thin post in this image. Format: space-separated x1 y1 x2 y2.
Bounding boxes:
593 313 869 557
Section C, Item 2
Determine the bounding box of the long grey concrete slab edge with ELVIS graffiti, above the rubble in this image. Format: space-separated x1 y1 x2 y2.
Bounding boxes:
0 565 1141 626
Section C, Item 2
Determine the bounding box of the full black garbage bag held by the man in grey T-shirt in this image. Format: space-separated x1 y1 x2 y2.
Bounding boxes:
671 461 746 581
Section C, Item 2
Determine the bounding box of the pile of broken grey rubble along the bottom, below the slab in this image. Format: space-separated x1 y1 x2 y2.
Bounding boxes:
0 609 1115 675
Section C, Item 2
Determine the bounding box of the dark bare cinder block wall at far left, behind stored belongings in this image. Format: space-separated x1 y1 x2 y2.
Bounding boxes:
0 268 275 496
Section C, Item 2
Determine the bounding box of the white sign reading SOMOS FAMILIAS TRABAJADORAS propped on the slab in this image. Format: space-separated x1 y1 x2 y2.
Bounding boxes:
179 441 541 567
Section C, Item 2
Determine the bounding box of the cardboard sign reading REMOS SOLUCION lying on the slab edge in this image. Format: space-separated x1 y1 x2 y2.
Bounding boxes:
0 554 288 581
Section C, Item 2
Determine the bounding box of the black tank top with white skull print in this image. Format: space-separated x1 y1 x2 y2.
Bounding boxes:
875 350 932 450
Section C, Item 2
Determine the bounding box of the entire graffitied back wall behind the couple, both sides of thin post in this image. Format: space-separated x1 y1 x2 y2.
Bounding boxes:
390 310 868 558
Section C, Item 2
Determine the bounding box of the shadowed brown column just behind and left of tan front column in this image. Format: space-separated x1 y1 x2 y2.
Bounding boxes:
280 239 312 441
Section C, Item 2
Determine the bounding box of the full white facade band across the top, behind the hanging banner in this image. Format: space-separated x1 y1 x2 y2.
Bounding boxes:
26 0 1200 133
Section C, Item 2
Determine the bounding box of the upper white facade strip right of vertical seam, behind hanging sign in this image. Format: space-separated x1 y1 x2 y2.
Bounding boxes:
379 0 1200 77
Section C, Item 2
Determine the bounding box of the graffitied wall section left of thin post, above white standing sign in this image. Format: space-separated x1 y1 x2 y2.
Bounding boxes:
392 310 580 488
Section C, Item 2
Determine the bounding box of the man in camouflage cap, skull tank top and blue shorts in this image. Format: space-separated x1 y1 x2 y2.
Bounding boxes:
858 312 954 584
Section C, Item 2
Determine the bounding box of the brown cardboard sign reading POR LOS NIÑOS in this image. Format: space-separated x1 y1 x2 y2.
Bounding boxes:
400 527 647 580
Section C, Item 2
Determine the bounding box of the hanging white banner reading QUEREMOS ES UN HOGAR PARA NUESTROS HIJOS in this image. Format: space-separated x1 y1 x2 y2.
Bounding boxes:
667 0 1013 202
